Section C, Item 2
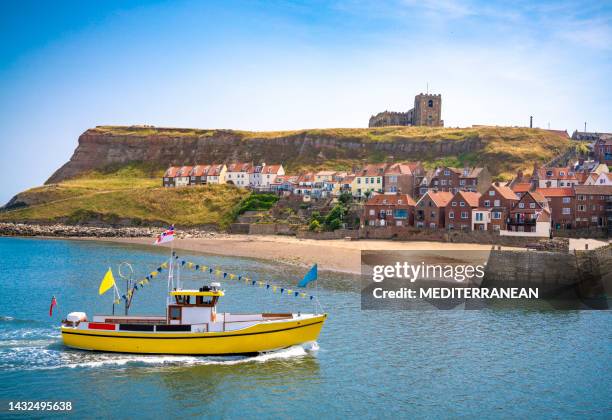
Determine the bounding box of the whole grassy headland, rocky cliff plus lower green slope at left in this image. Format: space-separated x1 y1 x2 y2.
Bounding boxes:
0 126 570 226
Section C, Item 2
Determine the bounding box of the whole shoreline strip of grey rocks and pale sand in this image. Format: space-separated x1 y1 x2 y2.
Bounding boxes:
0 223 607 275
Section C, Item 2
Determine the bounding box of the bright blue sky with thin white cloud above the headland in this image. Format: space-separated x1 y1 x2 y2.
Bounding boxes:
0 0 612 203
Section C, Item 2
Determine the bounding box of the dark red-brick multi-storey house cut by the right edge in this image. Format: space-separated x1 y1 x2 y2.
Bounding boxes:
574 185 612 228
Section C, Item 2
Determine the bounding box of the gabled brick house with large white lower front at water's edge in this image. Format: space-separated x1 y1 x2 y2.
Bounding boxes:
500 191 550 237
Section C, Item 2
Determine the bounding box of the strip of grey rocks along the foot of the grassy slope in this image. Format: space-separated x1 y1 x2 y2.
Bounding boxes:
0 223 217 238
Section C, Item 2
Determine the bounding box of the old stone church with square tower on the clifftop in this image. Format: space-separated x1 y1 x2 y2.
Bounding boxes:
368 93 444 127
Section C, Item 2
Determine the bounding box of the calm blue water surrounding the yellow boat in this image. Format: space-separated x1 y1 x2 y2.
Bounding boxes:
0 238 612 418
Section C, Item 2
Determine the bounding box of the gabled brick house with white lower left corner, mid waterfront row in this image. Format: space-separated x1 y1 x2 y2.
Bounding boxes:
472 182 529 232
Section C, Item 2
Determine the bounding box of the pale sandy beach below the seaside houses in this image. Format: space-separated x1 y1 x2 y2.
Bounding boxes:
85 234 510 274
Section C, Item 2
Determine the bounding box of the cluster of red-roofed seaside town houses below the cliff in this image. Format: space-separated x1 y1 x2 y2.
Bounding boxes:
163 128 612 237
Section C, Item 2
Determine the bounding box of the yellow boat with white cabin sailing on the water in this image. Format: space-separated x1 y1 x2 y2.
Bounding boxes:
61 283 327 355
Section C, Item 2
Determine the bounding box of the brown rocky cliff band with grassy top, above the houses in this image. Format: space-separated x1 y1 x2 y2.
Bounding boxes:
47 126 566 184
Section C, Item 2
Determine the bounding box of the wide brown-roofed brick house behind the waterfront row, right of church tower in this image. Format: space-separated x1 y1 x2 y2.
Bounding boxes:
429 166 491 194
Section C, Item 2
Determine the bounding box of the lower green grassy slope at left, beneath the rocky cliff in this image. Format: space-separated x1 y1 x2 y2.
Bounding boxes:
0 165 249 226
